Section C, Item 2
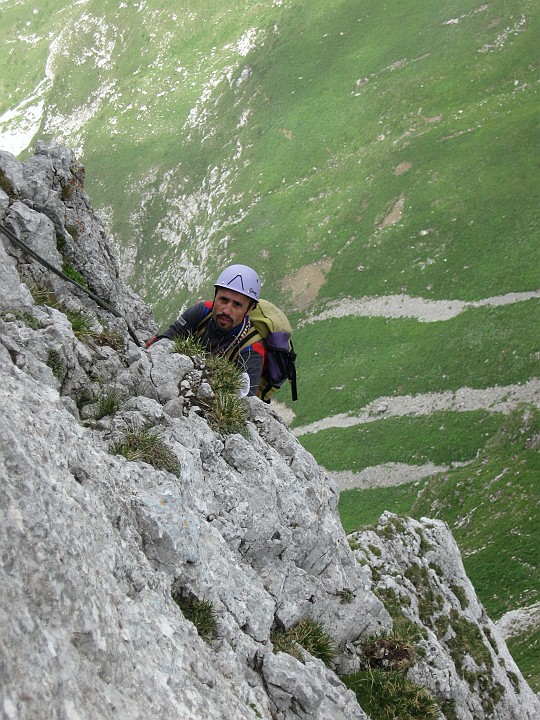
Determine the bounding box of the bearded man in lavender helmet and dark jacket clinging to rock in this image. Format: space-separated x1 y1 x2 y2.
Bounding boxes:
146 265 265 396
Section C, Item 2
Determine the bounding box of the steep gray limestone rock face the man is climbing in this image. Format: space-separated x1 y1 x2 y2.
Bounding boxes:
0 145 540 720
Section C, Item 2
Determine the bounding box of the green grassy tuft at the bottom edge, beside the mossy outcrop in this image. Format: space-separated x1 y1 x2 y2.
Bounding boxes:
341 668 439 720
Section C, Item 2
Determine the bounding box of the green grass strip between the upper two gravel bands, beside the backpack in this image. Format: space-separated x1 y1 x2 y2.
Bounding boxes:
292 300 540 426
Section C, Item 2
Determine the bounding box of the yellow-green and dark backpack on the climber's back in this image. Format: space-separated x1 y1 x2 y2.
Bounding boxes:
249 300 298 403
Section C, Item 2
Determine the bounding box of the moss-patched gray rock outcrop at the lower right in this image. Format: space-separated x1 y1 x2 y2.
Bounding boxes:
350 513 539 720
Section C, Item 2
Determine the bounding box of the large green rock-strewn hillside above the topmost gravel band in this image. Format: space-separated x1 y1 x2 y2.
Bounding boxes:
4 0 540 322
